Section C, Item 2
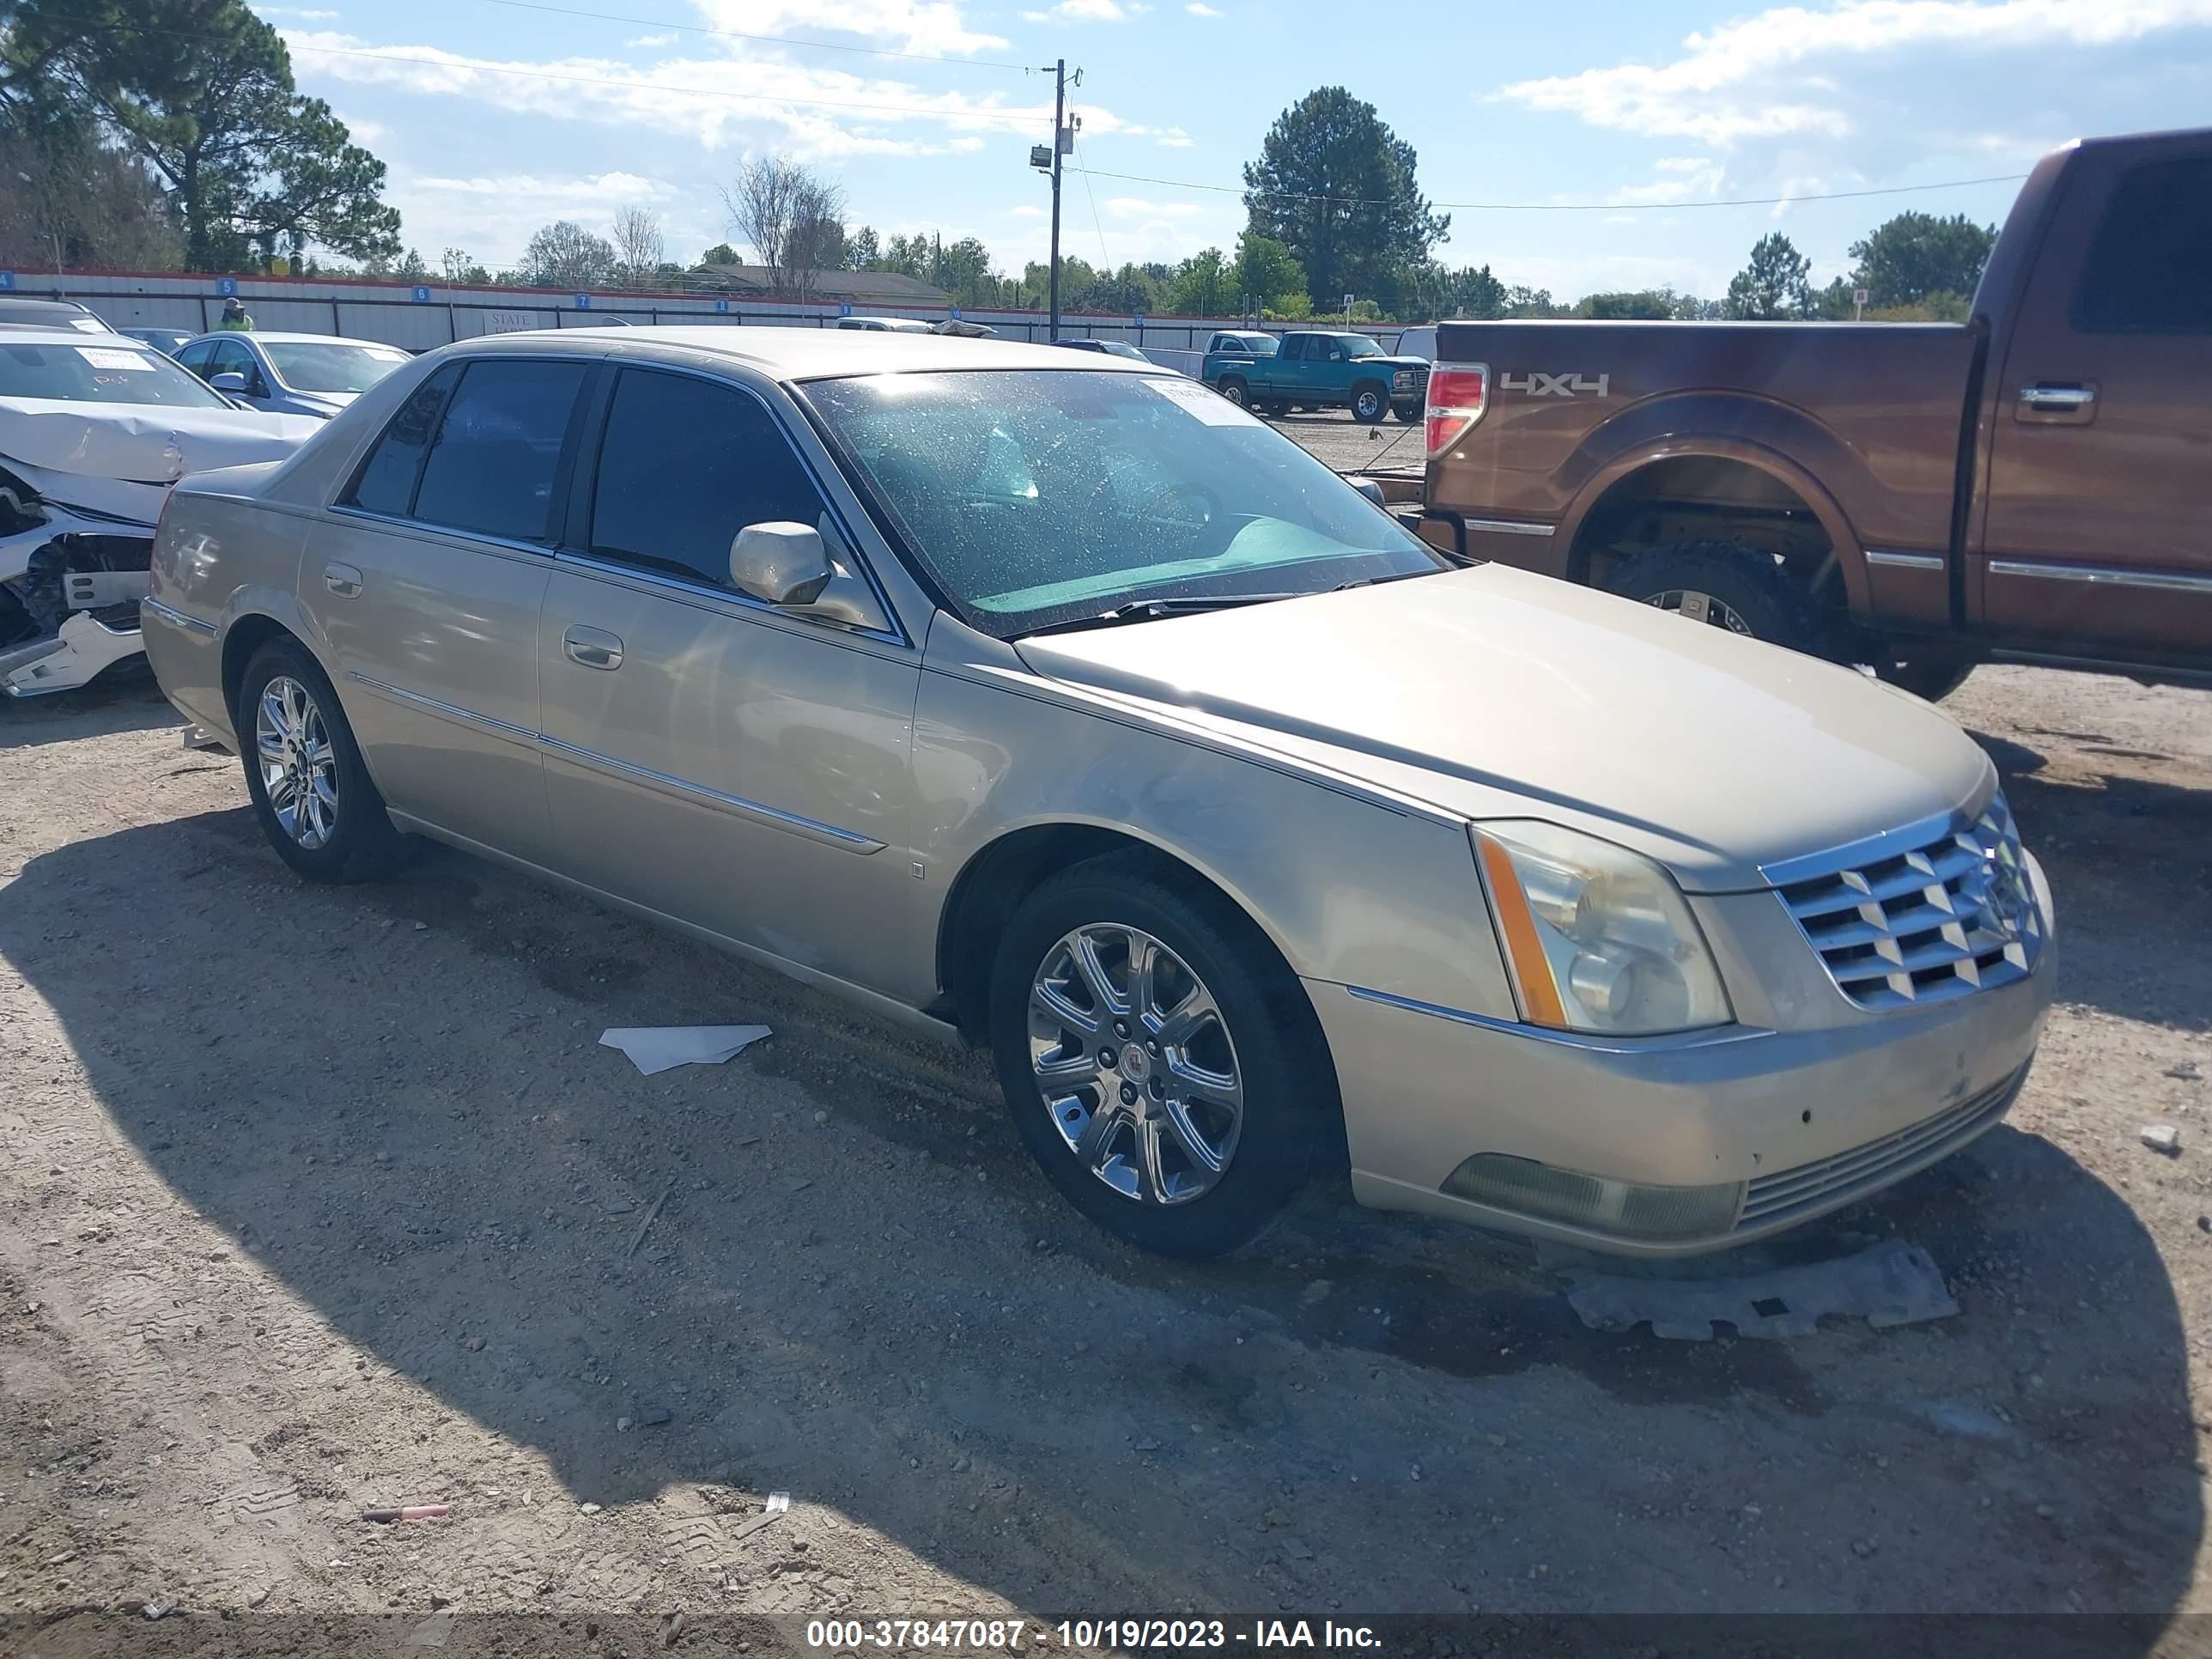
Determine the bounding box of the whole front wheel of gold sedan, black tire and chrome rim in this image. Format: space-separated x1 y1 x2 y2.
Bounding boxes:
991 854 1338 1259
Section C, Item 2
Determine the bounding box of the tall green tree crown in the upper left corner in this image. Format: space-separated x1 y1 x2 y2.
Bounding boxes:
0 0 400 270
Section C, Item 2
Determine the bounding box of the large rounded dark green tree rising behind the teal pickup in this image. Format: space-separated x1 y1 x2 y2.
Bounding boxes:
1243 86 1451 312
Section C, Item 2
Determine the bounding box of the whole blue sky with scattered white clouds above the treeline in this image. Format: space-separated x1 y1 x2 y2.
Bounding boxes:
257 0 2212 301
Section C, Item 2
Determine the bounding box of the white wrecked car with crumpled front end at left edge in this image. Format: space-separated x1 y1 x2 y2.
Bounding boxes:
0 330 323 696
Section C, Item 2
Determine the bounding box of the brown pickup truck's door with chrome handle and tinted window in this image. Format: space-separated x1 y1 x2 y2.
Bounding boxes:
1969 135 2212 657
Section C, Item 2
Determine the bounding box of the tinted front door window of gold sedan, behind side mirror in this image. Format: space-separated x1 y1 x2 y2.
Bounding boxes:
591 369 823 588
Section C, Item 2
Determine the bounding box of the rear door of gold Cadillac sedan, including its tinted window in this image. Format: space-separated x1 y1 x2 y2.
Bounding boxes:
299 354 591 865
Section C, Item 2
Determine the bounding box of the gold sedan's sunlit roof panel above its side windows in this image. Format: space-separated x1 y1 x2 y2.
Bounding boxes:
429 325 1161 380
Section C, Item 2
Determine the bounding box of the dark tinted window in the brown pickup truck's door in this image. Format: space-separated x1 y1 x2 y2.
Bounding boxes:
2075 155 2212 334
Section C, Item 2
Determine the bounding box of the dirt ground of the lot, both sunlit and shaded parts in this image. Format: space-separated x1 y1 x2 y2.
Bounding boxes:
0 654 2212 1655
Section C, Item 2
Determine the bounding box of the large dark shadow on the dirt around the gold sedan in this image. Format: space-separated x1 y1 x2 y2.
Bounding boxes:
0 803 2203 1617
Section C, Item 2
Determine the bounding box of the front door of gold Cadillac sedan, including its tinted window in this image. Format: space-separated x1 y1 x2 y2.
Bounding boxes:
538 365 921 987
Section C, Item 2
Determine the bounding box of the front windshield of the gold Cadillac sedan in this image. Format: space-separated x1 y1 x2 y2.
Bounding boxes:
805 369 1444 639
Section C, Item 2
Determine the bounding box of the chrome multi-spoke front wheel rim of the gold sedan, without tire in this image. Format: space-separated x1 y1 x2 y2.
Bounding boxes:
1029 922 1245 1206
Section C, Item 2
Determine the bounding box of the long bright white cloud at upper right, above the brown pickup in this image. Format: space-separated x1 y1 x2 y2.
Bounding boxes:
1498 0 2212 146
